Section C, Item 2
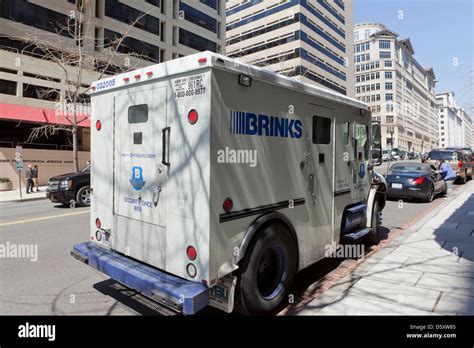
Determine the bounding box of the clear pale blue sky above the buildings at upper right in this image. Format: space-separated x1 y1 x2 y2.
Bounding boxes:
353 0 474 111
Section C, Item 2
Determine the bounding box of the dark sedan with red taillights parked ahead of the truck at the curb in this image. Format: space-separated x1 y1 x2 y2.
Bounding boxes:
385 162 446 202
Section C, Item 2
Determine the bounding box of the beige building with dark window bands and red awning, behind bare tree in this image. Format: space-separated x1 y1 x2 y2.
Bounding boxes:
0 0 225 188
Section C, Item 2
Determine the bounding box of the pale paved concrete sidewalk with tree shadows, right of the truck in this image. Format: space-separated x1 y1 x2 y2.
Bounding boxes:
292 181 474 315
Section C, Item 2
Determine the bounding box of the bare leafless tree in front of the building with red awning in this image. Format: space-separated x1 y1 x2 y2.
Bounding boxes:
14 0 156 171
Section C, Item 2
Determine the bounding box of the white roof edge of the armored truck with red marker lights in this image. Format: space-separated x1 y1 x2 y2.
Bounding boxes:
91 51 368 110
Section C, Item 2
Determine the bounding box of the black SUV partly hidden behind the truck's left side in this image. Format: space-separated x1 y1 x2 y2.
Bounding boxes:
46 165 91 207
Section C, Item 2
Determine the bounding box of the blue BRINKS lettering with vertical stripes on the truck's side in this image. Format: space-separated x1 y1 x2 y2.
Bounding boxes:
230 111 303 139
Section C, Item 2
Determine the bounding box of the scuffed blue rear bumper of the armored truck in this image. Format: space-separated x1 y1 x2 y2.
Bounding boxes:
71 242 209 315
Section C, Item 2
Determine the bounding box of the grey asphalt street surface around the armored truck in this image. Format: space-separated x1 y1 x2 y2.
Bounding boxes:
0 167 461 315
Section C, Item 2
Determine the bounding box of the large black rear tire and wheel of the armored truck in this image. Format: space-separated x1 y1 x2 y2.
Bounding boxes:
235 223 298 315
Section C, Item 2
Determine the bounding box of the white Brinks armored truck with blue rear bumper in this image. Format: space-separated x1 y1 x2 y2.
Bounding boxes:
72 52 385 315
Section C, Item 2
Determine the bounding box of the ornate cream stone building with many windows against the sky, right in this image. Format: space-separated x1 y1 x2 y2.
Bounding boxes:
354 23 439 152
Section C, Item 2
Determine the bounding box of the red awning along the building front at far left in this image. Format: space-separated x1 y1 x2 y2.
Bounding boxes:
0 103 91 128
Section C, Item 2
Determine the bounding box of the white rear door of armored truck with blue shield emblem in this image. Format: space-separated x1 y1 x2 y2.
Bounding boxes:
113 87 170 253
